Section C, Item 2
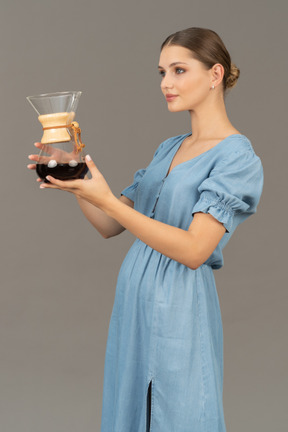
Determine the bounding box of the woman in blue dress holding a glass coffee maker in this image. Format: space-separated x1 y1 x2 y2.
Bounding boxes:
28 27 263 432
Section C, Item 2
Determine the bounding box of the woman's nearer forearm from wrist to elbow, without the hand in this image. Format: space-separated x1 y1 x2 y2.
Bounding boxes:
103 197 199 269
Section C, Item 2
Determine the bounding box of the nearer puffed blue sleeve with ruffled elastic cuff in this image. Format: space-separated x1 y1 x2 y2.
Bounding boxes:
192 150 264 232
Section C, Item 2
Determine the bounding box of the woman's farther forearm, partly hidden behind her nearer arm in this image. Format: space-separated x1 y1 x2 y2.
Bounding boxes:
77 197 125 238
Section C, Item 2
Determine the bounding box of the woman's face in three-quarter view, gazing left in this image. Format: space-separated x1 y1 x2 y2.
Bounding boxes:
159 45 212 112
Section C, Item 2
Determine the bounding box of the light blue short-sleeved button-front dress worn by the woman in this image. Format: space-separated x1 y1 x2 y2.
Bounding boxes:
101 133 263 432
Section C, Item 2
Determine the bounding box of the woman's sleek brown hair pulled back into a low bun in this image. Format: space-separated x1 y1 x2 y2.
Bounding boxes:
161 27 240 92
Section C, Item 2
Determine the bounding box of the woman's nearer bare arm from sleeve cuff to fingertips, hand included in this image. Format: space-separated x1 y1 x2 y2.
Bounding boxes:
40 156 226 270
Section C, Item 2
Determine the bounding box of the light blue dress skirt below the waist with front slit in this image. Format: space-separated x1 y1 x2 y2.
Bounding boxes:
101 239 225 432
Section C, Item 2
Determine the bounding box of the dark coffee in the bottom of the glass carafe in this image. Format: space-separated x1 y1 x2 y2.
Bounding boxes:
36 162 88 183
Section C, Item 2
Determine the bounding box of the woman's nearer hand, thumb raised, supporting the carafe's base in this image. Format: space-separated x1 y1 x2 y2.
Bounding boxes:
40 155 115 210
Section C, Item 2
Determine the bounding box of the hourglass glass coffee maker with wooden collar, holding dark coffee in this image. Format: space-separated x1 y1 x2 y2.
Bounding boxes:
27 91 88 183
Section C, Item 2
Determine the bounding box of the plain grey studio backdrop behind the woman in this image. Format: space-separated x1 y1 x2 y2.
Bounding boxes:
0 0 288 432
